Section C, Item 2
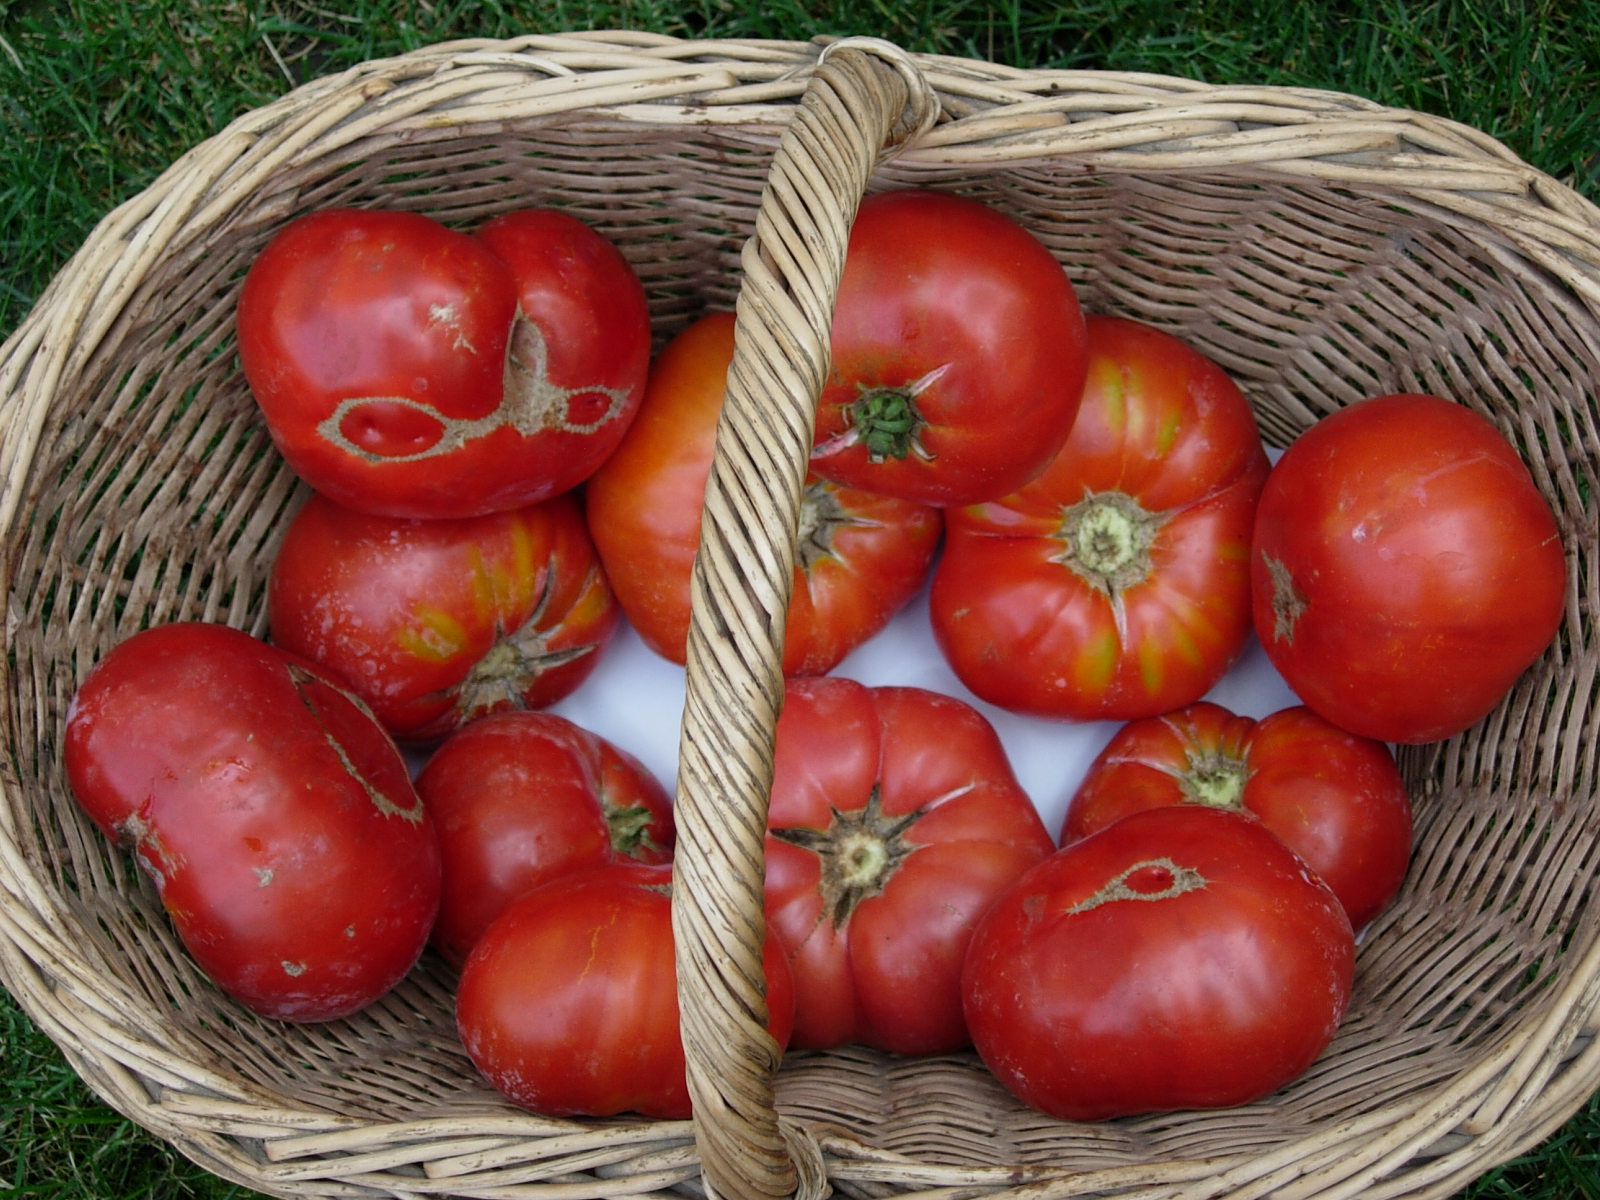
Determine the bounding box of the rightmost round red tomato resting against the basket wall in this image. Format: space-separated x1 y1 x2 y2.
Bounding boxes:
1251 394 1566 742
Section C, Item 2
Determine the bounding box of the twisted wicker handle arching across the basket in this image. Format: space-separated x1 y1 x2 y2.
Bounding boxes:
672 38 938 1200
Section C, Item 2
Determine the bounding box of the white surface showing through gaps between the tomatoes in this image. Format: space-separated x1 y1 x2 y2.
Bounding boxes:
550 560 1299 835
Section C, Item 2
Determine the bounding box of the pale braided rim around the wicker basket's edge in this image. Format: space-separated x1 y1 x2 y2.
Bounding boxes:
0 30 1600 1195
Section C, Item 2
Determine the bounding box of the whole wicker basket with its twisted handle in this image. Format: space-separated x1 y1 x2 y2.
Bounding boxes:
0 34 1600 1200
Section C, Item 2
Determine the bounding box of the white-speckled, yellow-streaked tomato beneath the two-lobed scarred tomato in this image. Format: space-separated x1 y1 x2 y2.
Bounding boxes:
267 493 621 742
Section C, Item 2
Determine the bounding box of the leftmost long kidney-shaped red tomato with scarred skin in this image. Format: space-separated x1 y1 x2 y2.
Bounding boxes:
64 622 440 1021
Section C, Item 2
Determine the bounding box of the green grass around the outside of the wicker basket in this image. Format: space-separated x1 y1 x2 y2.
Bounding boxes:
0 0 1600 1200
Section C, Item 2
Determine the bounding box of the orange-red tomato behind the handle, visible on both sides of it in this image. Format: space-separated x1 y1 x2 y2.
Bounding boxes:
584 312 942 675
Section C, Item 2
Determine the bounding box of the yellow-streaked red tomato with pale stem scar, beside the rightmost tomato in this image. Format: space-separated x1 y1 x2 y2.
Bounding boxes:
930 315 1269 720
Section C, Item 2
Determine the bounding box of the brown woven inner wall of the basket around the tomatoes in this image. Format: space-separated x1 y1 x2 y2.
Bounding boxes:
6 96 1600 1184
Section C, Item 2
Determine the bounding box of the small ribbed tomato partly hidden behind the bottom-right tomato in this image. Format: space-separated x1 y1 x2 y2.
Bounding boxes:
1061 701 1411 930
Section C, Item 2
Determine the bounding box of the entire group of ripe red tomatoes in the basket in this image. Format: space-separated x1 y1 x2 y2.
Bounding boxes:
64 189 1566 1120
